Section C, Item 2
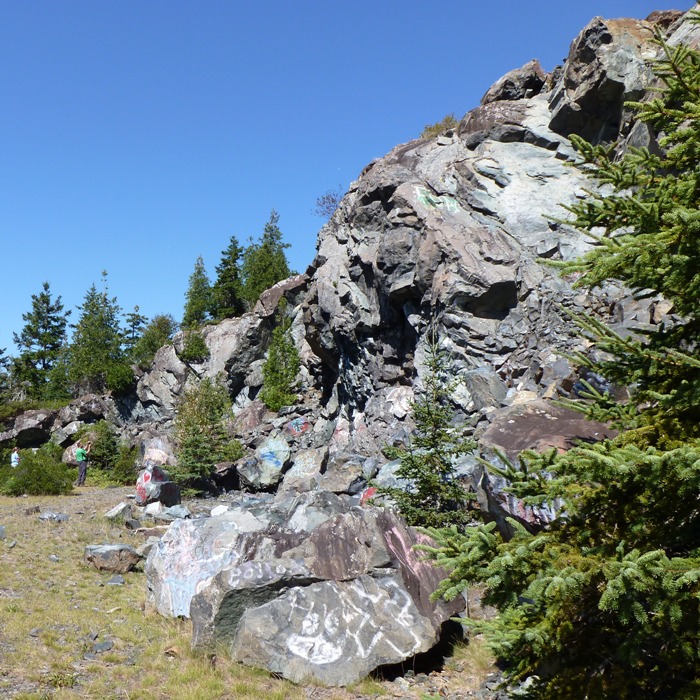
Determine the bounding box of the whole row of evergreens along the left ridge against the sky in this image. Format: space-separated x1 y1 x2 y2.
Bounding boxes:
0 210 292 403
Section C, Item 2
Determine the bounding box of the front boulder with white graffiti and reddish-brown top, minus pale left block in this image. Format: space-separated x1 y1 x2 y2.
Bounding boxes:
182 508 464 685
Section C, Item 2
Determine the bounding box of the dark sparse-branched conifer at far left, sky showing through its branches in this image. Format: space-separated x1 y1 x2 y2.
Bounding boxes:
13 282 71 399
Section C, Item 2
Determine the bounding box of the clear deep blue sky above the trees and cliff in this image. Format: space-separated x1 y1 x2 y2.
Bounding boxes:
0 0 694 355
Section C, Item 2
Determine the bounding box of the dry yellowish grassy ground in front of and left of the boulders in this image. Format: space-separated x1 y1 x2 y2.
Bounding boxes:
0 487 492 700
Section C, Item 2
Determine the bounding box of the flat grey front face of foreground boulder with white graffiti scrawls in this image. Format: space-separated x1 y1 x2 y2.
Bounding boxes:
231 572 437 686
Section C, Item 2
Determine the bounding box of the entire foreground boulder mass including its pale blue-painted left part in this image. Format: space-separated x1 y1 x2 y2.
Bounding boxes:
146 494 464 685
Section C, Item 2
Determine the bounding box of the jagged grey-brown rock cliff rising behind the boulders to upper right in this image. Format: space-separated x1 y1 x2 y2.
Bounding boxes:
0 12 699 470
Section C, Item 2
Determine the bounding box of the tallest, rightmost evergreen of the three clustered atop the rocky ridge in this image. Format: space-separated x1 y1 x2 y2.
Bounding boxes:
242 209 291 307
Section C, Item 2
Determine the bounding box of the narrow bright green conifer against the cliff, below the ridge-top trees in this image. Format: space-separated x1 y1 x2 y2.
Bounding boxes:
260 299 301 411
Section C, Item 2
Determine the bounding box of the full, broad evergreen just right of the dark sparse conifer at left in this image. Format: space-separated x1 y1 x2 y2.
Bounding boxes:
67 272 133 394
